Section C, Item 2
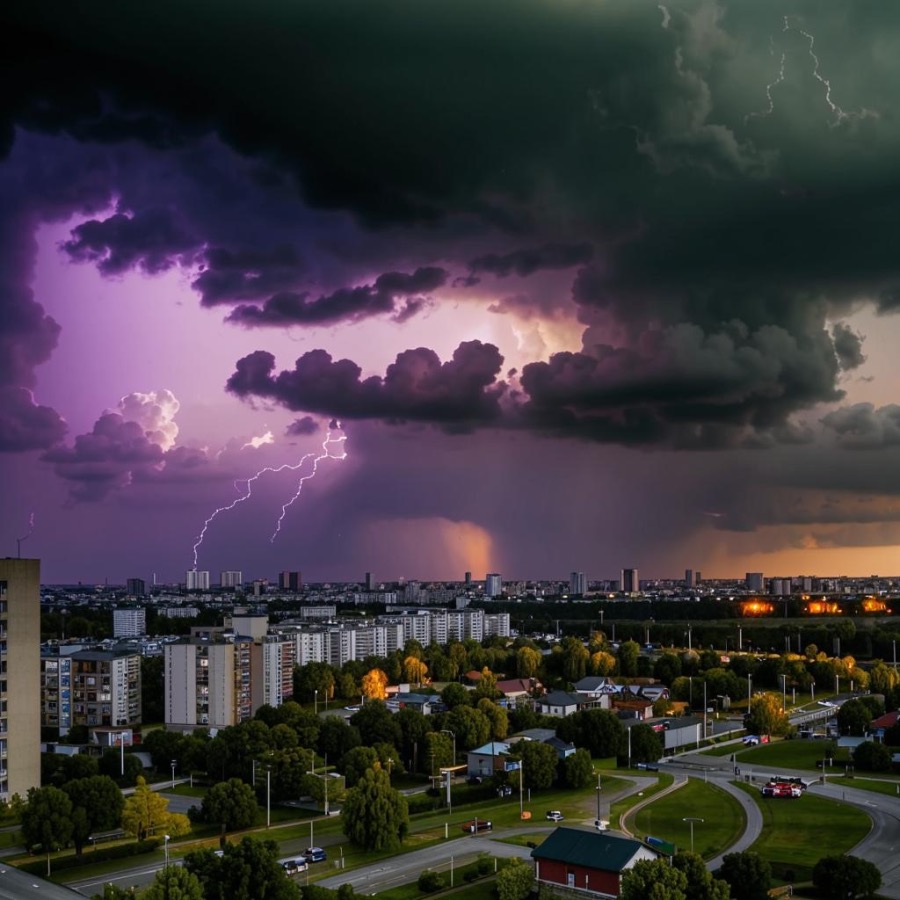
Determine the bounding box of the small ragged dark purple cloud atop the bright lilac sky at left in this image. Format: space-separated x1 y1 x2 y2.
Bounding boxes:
63 208 199 275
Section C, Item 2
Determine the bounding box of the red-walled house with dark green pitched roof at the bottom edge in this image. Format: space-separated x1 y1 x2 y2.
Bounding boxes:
531 828 659 900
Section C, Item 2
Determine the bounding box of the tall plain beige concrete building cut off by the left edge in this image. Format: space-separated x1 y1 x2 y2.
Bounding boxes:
0 559 41 800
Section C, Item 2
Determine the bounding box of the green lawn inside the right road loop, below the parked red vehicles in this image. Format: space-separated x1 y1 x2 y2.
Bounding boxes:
741 785 872 881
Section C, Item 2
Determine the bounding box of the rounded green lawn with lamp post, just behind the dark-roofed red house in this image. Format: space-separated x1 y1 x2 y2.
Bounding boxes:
633 778 746 859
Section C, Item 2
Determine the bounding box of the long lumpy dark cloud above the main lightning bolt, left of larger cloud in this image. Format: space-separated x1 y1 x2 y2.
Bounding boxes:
227 341 505 430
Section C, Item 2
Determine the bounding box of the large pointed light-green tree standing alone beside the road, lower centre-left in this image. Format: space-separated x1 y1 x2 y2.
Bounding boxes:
341 765 409 850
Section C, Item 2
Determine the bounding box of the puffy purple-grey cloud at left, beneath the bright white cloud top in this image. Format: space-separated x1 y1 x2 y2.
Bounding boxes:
43 413 165 501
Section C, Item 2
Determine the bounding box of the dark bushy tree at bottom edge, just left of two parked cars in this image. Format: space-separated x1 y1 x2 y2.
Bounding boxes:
184 837 300 900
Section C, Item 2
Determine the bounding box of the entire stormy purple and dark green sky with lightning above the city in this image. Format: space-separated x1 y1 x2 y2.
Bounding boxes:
0 0 900 583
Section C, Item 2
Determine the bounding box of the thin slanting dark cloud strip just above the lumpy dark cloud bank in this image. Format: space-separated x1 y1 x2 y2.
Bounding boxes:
226 266 447 328
